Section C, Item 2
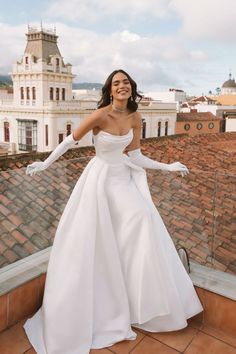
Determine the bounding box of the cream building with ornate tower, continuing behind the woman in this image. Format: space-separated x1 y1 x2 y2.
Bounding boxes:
0 26 176 153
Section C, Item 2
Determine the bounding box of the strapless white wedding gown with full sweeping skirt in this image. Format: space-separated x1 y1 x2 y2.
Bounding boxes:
24 129 203 354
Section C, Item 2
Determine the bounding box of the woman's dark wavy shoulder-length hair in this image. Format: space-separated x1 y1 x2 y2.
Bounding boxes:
98 69 142 112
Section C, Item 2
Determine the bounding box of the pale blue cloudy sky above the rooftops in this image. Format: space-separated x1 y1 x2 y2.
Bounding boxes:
0 0 236 94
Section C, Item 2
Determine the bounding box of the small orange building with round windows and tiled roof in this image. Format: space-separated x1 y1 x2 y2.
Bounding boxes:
176 110 221 135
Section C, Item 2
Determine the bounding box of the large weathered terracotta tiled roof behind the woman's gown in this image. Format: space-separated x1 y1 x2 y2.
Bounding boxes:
0 133 236 274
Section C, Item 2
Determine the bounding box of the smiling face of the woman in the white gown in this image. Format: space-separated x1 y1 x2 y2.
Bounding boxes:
111 72 132 100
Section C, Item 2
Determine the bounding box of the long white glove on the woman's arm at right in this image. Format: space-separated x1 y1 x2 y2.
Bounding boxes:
128 149 189 177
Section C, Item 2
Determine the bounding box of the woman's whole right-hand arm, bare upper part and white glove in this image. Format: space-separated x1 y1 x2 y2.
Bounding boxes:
127 113 189 177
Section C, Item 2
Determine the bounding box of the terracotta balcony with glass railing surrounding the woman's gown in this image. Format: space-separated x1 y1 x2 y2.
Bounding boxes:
0 153 236 354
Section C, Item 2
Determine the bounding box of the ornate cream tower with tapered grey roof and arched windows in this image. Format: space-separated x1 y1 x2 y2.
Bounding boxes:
12 25 74 108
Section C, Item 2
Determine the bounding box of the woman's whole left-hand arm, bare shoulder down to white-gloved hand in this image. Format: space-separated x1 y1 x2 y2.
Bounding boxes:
26 110 102 176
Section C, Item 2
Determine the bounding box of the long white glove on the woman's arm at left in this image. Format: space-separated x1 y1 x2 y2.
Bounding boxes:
26 134 76 176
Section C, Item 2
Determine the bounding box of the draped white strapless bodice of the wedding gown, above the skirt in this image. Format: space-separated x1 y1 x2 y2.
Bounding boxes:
94 129 133 164
